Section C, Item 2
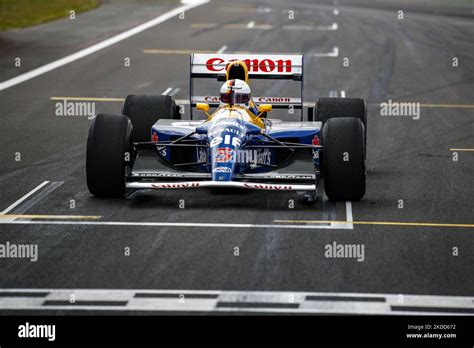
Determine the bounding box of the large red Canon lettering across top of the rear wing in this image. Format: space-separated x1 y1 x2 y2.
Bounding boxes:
206 57 292 73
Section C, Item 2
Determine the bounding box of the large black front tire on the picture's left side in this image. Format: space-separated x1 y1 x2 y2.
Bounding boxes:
86 114 133 197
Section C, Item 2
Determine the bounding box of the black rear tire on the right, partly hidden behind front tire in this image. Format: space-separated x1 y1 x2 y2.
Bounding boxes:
316 98 367 138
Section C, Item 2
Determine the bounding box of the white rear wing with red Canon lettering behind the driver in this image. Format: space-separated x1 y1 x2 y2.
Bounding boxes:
189 53 303 120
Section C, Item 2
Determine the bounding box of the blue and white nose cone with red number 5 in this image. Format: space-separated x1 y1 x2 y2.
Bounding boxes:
208 119 247 181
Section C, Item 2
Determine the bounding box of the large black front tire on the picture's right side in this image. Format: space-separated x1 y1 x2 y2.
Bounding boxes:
322 117 365 201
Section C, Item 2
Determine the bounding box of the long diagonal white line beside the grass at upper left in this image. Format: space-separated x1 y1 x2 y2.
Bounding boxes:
0 0 209 91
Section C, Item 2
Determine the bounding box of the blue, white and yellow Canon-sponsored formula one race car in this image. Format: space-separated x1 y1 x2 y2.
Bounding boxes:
86 54 367 200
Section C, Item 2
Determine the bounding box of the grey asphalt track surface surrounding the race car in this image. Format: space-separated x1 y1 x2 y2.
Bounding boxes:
0 0 474 316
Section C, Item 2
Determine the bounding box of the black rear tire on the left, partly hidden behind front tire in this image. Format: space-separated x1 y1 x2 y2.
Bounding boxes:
122 95 180 142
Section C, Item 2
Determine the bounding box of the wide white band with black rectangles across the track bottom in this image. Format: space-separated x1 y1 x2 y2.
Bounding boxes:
0 289 473 315
